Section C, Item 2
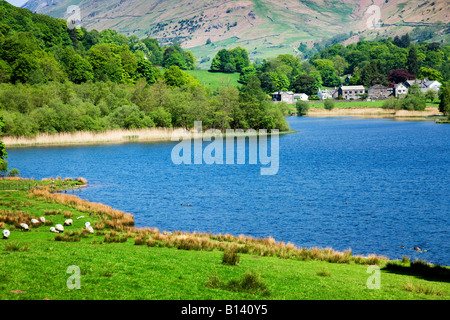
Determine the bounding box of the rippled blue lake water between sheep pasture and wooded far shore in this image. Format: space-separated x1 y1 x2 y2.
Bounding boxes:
7 117 450 265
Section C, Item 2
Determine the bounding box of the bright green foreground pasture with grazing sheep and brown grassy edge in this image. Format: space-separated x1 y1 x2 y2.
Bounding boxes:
0 180 450 300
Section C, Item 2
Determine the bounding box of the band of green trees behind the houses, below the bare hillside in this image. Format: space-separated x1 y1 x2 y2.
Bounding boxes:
224 34 450 98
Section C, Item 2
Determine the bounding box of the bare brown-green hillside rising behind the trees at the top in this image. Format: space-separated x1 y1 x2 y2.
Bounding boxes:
24 0 450 68
